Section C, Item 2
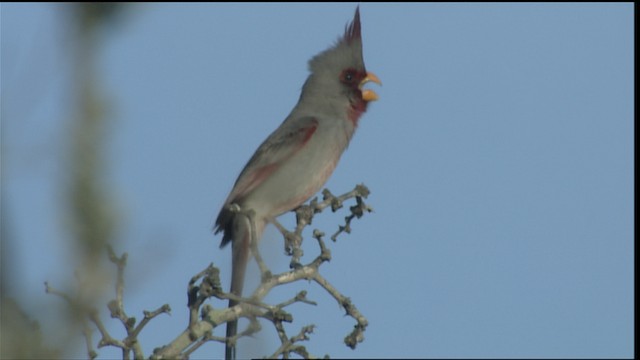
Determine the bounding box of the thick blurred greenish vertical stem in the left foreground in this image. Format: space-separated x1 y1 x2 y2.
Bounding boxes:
68 3 119 268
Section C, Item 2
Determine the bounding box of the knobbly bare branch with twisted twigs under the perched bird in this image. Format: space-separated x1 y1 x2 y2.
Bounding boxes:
51 185 372 359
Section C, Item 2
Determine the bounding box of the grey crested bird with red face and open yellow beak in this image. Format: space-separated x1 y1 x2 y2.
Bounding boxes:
214 6 382 359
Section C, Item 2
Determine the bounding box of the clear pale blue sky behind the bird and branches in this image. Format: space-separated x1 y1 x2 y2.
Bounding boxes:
1 3 634 358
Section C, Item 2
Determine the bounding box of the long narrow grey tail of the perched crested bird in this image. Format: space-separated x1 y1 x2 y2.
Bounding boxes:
225 215 265 360
